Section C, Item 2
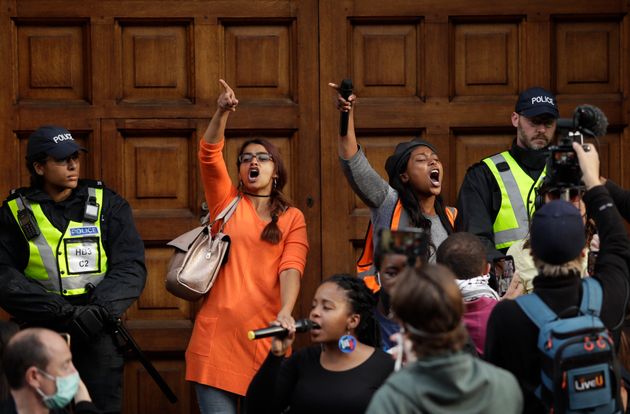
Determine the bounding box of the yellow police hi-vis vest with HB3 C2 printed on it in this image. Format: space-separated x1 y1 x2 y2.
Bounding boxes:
9 187 107 296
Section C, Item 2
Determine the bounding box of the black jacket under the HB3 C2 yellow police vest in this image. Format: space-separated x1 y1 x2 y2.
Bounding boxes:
0 180 146 330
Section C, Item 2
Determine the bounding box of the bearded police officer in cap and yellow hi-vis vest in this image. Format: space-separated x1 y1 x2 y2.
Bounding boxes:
456 87 558 262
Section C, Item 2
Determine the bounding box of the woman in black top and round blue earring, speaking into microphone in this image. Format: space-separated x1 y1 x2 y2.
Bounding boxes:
246 275 394 414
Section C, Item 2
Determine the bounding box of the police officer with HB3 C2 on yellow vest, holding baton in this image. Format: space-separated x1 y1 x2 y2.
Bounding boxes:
0 126 146 413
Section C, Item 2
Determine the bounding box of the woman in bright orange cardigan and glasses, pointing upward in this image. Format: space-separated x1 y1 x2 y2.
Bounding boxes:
186 80 308 414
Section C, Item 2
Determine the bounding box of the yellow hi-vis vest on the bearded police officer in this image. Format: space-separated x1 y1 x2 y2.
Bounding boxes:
483 151 547 250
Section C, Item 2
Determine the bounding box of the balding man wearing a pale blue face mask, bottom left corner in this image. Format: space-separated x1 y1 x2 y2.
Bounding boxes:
2 328 101 414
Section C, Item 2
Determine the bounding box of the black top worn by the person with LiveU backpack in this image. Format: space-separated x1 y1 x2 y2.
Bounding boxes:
485 186 630 413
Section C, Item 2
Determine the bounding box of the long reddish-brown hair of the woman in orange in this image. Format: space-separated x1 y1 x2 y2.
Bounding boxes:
236 138 293 244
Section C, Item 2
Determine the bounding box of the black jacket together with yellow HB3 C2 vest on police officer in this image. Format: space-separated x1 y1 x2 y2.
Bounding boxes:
0 179 146 322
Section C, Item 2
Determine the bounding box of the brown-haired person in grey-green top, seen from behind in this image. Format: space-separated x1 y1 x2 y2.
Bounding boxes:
366 263 523 414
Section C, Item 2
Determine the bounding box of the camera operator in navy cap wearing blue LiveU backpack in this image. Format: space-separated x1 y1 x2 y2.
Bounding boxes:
485 142 630 413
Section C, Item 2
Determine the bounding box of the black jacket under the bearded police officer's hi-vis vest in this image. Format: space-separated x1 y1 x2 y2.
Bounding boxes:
455 140 548 262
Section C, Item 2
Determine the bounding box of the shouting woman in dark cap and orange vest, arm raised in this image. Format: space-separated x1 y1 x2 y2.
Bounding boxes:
328 83 457 292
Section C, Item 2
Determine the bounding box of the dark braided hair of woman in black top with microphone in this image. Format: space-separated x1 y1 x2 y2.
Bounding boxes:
322 273 381 347
